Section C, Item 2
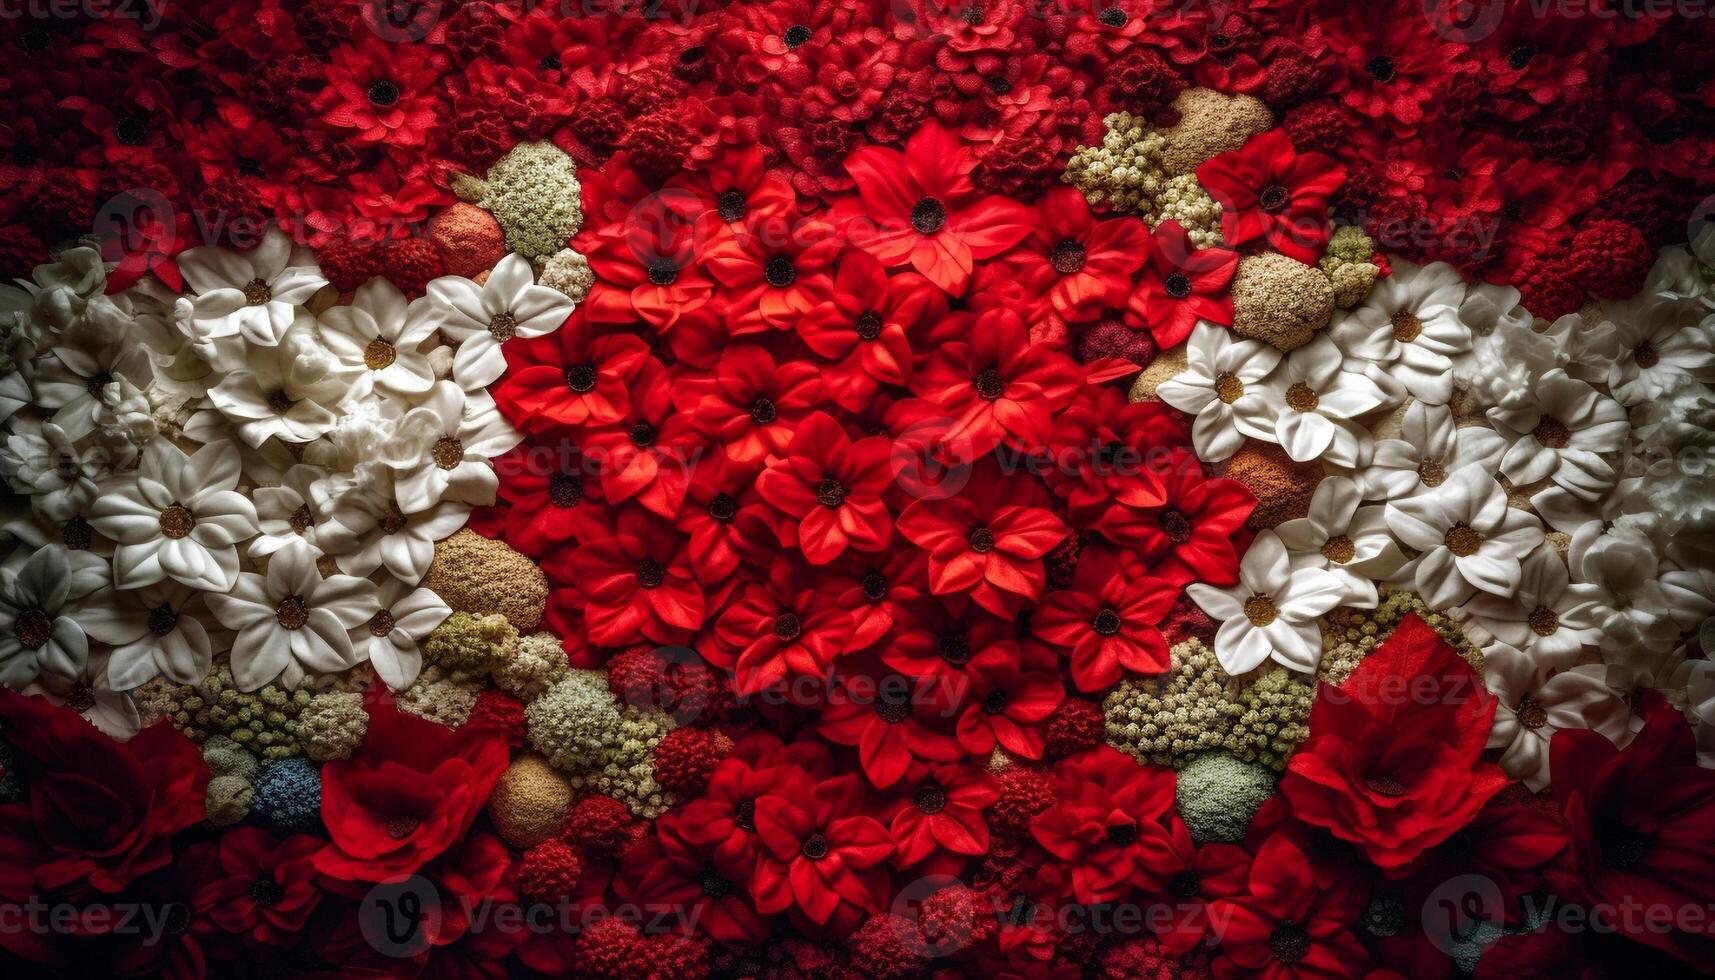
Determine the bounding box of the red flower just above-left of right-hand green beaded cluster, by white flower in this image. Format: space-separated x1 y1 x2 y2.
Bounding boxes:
1031 547 1180 692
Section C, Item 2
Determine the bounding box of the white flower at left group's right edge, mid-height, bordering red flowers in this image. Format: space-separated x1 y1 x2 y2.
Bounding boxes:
396 381 520 513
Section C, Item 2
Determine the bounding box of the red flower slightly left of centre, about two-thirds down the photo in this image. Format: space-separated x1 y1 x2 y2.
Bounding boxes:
703 560 852 697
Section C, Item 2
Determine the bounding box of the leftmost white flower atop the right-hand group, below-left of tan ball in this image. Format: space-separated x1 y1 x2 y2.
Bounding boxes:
1156 319 1281 462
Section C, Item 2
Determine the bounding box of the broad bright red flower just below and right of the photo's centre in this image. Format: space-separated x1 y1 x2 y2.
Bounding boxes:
899 458 1068 616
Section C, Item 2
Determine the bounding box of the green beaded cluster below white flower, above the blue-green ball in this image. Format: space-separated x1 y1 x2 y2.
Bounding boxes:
1103 638 1315 771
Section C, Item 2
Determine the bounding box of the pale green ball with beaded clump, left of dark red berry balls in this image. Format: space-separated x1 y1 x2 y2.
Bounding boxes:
525 669 672 819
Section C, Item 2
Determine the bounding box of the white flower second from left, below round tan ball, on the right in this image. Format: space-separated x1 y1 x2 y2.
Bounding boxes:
1262 335 1403 467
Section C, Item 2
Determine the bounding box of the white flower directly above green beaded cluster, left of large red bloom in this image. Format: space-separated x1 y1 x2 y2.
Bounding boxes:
1185 530 1343 676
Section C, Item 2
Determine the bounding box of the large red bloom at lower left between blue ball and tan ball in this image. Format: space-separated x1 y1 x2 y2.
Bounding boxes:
316 695 508 882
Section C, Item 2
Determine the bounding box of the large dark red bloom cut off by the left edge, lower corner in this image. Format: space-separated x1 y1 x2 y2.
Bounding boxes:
0 690 208 901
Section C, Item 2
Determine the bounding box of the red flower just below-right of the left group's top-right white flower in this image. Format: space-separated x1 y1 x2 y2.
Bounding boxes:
494 316 664 433
